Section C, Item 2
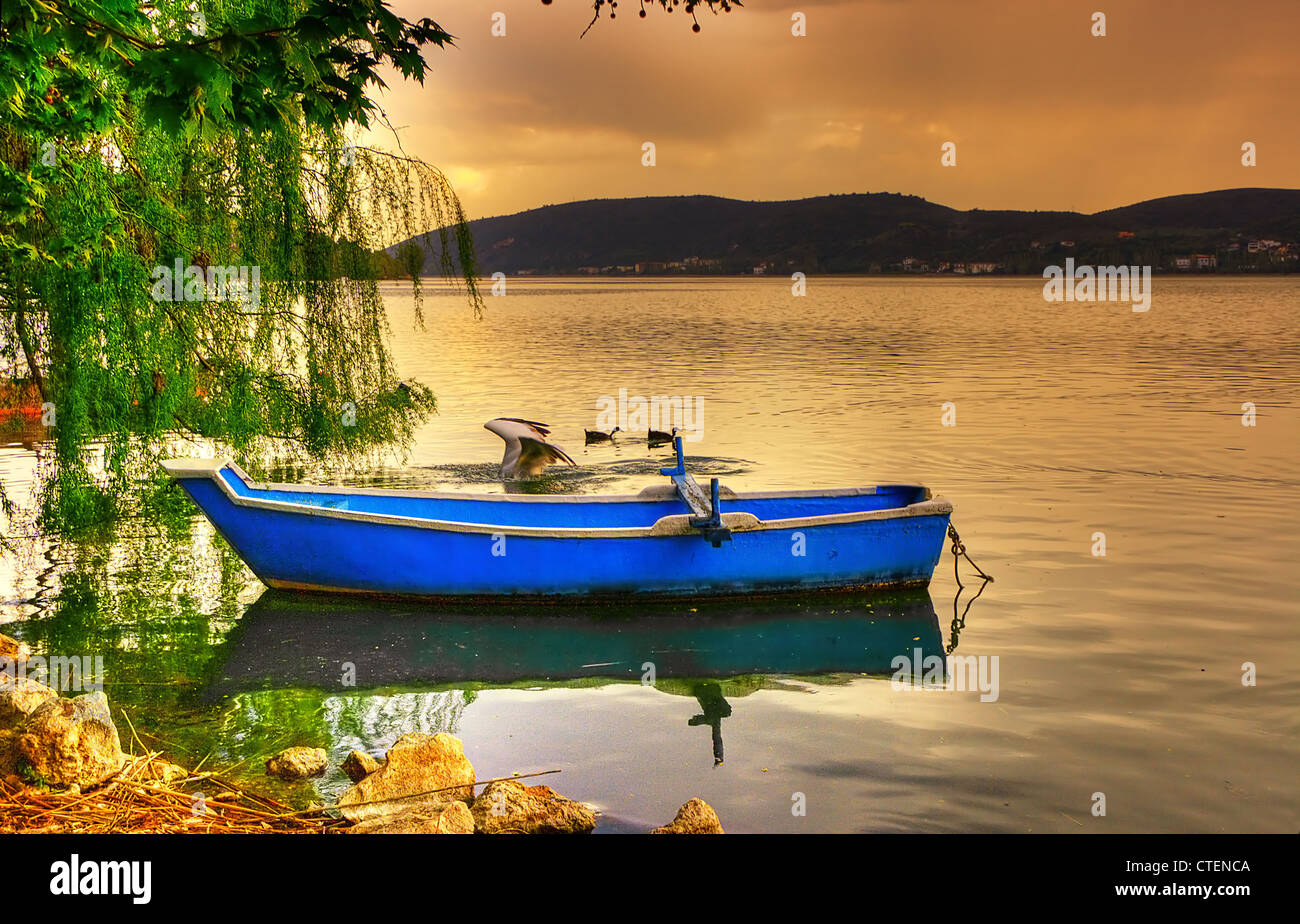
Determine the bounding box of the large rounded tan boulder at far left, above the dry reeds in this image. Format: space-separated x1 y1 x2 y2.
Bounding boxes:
18 693 126 789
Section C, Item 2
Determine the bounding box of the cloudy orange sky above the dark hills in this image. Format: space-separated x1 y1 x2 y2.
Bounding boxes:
361 0 1300 217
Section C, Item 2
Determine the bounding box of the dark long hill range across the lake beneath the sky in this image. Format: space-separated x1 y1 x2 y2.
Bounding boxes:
389 188 1300 276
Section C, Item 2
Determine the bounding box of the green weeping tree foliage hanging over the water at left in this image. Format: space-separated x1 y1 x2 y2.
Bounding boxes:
0 0 481 528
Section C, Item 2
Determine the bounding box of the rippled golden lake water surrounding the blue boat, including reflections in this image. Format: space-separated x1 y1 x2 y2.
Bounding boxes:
0 277 1300 833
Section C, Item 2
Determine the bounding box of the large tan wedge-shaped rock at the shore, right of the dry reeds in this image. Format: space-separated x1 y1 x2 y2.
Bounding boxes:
338 732 475 824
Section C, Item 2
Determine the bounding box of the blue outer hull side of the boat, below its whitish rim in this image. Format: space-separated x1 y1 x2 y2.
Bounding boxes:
173 460 952 599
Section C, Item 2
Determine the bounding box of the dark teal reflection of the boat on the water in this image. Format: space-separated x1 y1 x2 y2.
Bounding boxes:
205 590 946 763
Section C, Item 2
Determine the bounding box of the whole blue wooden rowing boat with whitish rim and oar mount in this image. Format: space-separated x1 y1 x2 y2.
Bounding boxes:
163 438 952 599
